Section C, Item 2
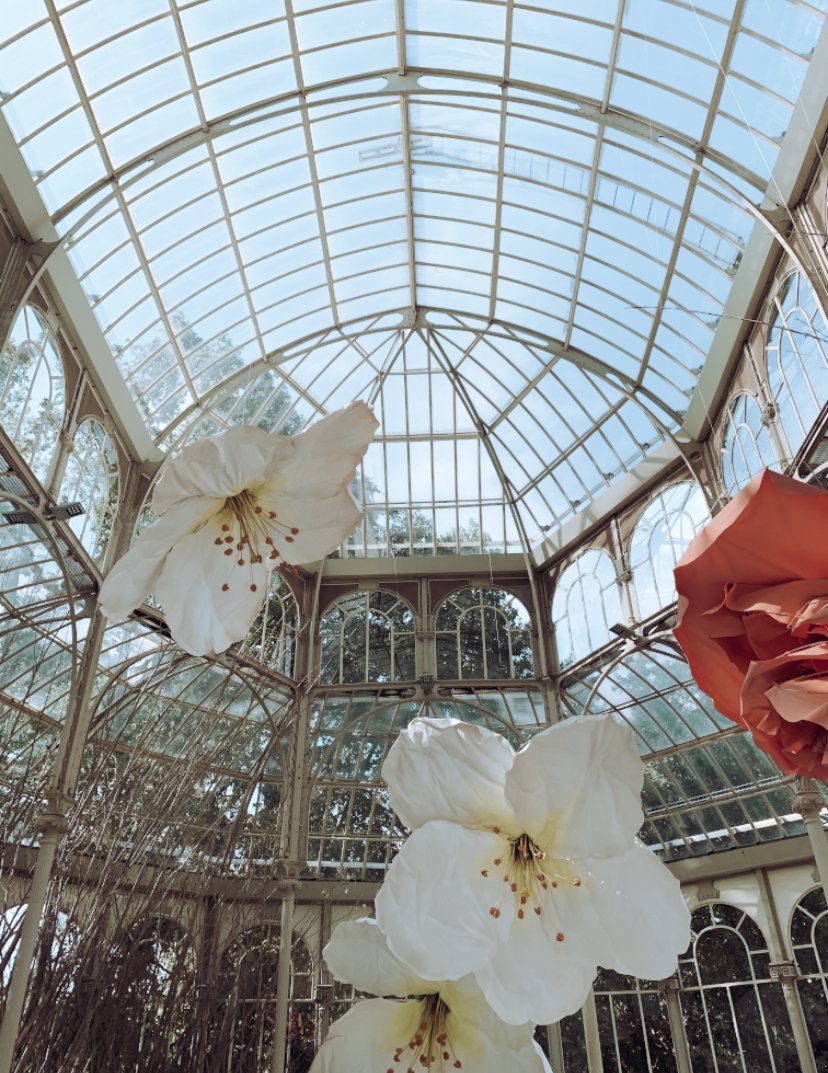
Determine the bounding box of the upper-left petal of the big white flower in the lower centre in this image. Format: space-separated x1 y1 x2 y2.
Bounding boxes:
382 718 519 834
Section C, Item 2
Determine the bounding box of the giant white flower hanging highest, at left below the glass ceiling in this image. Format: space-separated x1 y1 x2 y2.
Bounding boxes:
100 402 378 656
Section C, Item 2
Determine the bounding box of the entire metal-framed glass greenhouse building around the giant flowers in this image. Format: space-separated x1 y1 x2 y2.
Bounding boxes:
0 6 828 1073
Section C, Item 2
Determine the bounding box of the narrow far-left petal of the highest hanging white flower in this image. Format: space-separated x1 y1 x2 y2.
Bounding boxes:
99 496 224 622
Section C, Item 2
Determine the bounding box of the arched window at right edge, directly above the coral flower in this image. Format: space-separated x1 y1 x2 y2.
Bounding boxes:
766 273 828 458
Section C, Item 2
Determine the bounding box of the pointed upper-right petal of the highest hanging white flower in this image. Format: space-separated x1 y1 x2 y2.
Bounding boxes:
268 402 379 497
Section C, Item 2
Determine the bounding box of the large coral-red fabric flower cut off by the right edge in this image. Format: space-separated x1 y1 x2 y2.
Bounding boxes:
676 470 828 779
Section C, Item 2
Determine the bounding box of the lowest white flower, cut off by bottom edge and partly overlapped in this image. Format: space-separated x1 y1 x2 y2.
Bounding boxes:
311 920 550 1073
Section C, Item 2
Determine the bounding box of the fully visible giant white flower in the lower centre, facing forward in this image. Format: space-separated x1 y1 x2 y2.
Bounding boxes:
376 716 690 1024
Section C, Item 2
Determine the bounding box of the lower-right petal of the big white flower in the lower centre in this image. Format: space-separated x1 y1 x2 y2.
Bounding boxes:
580 846 691 980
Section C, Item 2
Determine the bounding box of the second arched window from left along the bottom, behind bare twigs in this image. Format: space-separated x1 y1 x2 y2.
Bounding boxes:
93 917 198 1073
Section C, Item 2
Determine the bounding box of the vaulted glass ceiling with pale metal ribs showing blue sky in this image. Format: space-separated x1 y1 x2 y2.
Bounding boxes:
0 0 826 554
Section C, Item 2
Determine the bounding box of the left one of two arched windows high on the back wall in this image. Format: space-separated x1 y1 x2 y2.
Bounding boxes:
320 591 414 682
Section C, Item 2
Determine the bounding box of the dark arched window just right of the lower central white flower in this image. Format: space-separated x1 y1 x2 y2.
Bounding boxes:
679 902 799 1073
